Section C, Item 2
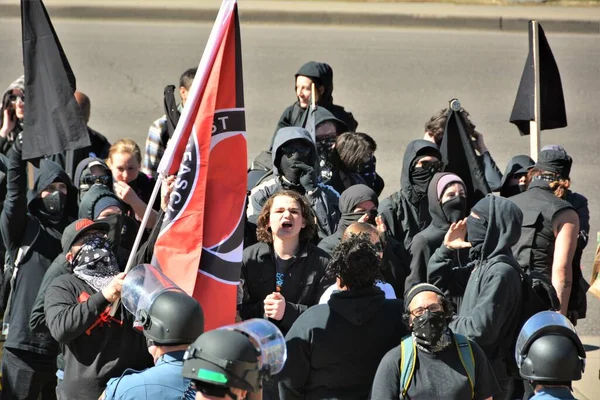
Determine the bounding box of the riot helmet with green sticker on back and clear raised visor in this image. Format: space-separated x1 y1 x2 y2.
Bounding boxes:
183 319 287 398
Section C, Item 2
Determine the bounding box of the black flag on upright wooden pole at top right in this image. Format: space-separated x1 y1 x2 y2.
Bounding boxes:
510 21 567 135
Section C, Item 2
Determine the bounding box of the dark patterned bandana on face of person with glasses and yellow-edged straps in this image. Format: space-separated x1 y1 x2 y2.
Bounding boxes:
412 311 452 353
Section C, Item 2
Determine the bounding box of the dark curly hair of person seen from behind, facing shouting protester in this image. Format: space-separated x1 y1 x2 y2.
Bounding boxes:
326 233 383 290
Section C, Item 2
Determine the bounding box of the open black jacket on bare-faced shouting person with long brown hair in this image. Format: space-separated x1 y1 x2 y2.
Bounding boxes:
240 242 333 333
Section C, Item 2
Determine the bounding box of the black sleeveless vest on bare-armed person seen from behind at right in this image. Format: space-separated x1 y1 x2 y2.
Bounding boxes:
510 180 573 279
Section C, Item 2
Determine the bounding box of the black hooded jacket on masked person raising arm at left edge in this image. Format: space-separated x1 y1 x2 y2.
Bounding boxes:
0 142 77 357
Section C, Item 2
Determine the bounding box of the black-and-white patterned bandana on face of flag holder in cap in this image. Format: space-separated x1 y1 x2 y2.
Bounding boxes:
72 235 119 292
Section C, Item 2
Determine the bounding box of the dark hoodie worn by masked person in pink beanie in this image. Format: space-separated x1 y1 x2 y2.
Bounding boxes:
405 172 469 290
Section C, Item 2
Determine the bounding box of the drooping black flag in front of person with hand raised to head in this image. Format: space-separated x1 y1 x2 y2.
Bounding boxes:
440 100 491 209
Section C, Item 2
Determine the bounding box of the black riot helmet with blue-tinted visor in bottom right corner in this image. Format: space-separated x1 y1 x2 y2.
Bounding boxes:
515 311 585 384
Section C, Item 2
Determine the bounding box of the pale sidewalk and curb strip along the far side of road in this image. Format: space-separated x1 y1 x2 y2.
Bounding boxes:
0 0 600 34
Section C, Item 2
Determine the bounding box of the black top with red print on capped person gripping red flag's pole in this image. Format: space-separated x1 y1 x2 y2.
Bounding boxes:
44 274 153 400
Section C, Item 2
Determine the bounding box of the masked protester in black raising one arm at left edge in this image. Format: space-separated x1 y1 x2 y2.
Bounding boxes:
0 139 77 399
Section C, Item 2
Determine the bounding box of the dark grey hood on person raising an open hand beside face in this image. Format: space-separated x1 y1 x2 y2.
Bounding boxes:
471 194 523 260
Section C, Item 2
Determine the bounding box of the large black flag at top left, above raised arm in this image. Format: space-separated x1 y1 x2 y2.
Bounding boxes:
21 0 90 160
